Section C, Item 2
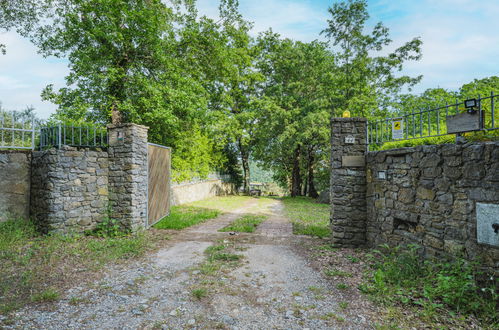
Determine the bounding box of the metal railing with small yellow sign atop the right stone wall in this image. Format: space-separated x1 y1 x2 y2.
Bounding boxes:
367 92 499 145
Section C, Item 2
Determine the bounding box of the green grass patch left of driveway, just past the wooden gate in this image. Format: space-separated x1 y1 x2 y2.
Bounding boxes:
154 205 220 230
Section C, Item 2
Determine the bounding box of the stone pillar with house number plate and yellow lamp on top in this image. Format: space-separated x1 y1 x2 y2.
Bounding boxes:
330 118 367 247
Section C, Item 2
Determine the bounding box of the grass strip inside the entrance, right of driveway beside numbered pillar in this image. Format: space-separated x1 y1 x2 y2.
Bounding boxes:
282 197 331 238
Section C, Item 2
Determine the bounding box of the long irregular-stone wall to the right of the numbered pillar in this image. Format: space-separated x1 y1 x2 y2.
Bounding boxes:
366 142 499 271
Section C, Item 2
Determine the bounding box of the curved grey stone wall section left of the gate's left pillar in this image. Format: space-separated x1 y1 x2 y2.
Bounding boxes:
31 146 109 232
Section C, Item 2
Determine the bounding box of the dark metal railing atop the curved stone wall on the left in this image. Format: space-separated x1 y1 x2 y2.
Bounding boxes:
39 125 108 149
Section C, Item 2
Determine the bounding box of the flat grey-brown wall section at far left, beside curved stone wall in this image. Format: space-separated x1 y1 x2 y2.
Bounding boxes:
0 150 31 221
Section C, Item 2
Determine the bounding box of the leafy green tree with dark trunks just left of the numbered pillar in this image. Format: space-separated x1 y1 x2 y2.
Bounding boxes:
256 31 332 196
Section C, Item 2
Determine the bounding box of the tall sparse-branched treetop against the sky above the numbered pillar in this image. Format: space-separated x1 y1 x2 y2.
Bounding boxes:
322 0 422 117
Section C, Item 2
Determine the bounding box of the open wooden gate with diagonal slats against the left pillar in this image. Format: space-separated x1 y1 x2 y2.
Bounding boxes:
147 143 171 226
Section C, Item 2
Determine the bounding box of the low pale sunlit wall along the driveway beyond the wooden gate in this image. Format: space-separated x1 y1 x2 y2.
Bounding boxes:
172 179 233 205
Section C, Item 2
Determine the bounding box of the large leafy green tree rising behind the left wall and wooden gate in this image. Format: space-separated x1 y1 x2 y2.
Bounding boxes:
0 0 254 180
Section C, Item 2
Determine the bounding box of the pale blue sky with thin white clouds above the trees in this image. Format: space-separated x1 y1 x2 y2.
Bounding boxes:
0 0 499 118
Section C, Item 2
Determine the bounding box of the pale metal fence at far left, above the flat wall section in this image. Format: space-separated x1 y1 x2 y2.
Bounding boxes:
0 112 36 149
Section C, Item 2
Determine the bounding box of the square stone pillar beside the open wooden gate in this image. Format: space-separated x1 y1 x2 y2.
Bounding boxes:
108 124 148 232
